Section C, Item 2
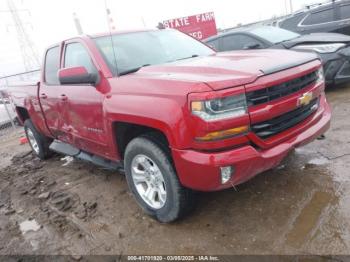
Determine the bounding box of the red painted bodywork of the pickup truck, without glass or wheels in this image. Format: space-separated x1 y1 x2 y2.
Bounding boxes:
10 30 330 191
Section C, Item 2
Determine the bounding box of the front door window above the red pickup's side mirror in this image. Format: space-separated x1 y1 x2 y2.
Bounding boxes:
64 43 96 73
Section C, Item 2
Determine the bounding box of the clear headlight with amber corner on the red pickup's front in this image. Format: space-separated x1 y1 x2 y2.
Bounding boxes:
191 94 247 122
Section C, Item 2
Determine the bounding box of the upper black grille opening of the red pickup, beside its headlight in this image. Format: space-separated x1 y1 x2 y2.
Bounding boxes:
247 71 317 106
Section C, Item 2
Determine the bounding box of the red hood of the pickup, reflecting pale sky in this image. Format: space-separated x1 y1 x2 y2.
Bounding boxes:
133 50 317 90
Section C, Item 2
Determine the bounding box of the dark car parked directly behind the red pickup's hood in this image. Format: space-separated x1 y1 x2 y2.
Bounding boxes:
204 26 350 84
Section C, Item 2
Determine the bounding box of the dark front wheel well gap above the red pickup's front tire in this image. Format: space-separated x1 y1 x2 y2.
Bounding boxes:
114 122 169 159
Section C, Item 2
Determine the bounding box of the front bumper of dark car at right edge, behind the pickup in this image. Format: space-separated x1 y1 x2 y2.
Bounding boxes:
320 47 350 84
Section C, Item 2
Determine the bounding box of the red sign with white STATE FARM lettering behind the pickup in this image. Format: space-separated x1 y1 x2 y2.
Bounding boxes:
163 12 217 40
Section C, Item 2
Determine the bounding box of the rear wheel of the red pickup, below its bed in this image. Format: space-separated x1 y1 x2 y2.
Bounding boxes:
24 119 52 160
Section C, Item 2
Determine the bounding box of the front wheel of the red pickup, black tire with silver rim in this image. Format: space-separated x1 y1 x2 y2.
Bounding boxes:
124 135 196 223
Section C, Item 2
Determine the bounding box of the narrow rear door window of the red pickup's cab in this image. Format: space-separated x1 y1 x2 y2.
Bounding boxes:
45 46 60 85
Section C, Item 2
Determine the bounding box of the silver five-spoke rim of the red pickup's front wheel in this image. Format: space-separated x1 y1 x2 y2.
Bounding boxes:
131 155 166 209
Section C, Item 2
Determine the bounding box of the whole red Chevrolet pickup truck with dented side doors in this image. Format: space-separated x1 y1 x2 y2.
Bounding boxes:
10 29 331 222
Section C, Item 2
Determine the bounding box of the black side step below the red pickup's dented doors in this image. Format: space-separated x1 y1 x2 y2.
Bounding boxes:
49 140 124 173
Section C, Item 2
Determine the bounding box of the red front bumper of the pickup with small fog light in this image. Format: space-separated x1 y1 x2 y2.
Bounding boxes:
172 96 331 191
